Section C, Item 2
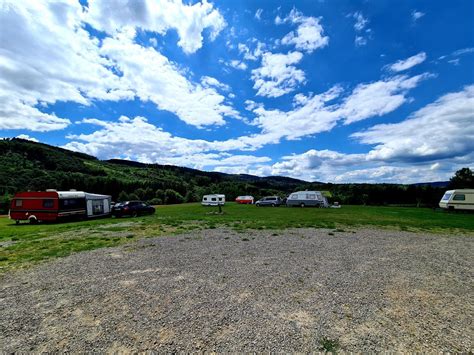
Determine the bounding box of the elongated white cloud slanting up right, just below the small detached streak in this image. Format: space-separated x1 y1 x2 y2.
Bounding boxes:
339 73 431 124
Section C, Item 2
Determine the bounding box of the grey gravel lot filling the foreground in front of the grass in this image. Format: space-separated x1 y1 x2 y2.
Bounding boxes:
0 229 474 352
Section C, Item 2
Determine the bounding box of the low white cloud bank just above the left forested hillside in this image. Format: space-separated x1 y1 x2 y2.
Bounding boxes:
64 116 271 170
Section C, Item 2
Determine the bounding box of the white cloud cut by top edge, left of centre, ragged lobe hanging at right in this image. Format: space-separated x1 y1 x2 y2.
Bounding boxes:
85 0 226 53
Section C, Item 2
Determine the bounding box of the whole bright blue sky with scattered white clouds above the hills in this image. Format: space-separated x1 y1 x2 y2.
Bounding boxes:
0 0 474 183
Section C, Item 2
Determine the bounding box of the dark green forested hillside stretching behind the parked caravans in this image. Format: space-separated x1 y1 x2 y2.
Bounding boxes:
0 138 452 211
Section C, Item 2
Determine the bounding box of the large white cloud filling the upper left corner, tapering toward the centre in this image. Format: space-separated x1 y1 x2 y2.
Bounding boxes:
0 0 238 131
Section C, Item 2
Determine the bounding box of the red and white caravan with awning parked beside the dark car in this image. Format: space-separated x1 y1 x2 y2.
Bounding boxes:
9 190 112 223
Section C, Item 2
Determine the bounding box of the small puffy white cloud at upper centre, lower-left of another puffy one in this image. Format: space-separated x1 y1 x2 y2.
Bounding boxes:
252 52 305 97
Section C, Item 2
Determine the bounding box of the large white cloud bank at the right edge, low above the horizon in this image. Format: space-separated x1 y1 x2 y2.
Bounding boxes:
269 85 474 183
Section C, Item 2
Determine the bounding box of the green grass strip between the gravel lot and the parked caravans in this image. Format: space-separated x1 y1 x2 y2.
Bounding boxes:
0 203 474 273
